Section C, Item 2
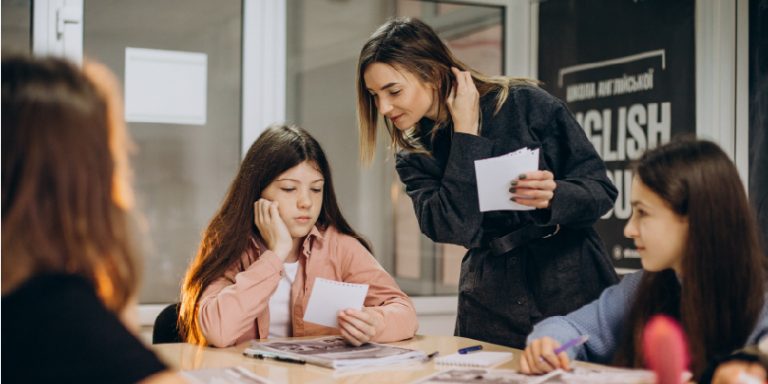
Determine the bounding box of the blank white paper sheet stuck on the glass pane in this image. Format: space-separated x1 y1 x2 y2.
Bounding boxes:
125 47 208 125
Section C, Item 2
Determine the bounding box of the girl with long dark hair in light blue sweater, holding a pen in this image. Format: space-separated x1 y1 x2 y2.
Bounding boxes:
521 139 768 381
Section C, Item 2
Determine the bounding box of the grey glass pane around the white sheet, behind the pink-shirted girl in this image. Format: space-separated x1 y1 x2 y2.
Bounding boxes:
83 0 242 303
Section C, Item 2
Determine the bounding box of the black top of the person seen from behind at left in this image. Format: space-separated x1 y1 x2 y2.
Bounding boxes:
2 274 167 384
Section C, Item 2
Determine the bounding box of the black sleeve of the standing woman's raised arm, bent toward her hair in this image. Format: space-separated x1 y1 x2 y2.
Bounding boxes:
395 133 493 248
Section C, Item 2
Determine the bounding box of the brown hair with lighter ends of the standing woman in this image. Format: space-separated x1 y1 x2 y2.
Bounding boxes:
357 17 536 164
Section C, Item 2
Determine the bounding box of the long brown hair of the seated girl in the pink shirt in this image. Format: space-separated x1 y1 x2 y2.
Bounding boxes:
179 125 371 344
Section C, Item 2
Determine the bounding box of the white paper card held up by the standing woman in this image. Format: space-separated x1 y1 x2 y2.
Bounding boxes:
475 148 539 212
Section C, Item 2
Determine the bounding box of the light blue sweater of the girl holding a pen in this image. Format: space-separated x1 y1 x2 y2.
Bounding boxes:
528 271 768 363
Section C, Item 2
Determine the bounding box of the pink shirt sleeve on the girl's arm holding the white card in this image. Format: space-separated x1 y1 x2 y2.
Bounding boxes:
337 236 419 343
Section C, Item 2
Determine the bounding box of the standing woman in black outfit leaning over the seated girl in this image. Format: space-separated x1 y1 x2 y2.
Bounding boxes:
357 18 617 348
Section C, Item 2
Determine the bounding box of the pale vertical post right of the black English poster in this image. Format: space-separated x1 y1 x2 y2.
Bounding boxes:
696 0 736 158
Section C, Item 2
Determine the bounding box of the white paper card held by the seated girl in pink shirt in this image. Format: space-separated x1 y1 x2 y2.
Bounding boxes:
304 277 368 328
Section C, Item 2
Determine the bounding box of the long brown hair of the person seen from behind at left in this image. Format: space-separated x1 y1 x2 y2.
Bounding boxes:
2 57 138 312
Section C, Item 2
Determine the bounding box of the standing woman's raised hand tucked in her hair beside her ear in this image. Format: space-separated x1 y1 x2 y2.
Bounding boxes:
446 67 480 135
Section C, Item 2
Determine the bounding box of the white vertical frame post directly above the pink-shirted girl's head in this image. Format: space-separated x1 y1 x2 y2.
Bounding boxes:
241 0 286 156
